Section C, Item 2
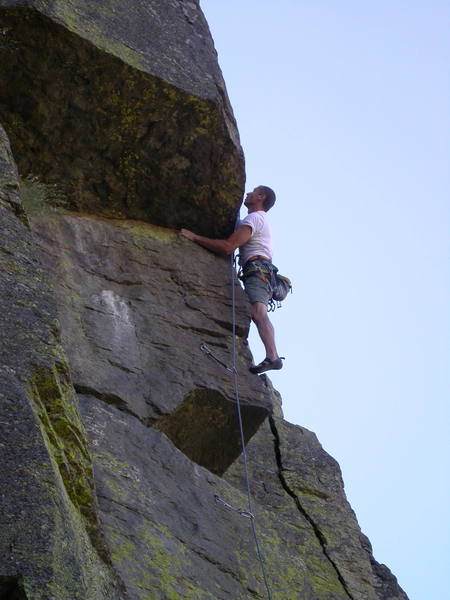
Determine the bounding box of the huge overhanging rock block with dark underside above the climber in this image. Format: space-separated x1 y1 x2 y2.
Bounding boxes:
0 0 244 237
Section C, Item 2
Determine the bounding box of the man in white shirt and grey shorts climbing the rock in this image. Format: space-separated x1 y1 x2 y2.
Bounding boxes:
181 185 283 374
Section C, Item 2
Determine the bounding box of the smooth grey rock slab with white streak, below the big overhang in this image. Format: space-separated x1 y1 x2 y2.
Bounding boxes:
32 214 271 474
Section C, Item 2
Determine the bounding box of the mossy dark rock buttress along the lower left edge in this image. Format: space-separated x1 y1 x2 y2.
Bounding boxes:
0 129 121 600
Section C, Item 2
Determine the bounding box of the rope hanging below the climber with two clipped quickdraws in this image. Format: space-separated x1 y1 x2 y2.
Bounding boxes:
200 254 272 600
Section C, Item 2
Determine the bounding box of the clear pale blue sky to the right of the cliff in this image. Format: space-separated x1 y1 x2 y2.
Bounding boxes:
201 0 450 600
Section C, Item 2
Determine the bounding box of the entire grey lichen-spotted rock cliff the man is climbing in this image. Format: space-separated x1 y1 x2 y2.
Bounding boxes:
0 0 406 600
